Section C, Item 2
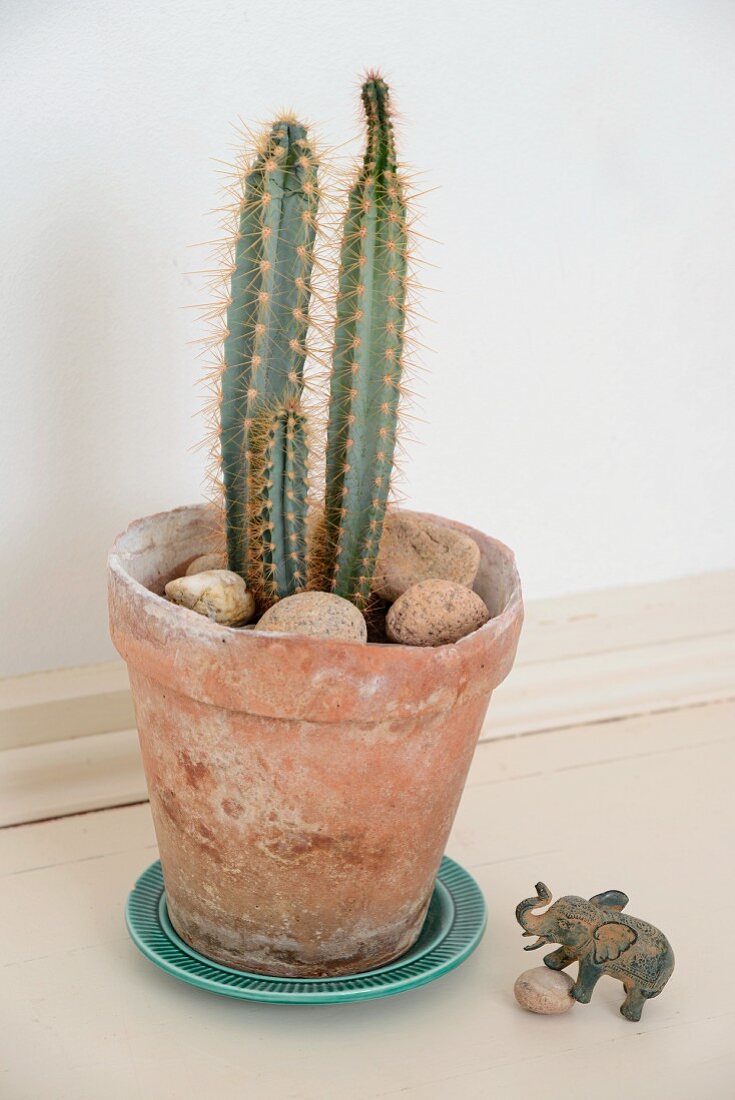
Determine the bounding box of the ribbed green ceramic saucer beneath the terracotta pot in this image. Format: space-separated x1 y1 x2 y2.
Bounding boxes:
125 856 486 1004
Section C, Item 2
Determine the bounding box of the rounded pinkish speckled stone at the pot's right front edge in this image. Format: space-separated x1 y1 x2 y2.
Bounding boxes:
385 581 490 646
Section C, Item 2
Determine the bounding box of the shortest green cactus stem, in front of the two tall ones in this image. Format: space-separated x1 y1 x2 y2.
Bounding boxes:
248 400 308 607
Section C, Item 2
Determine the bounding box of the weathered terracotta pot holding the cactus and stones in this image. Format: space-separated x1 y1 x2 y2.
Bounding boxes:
109 506 523 977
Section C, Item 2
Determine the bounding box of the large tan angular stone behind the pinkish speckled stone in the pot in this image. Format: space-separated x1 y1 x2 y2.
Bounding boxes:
373 512 480 603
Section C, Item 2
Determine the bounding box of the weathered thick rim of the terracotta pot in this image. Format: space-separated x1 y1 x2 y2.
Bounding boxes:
108 504 523 724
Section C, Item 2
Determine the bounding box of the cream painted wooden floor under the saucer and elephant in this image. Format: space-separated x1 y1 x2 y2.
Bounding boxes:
0 703 735 1100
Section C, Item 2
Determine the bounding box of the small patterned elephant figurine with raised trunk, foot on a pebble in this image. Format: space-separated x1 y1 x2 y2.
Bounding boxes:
516 882 673 1021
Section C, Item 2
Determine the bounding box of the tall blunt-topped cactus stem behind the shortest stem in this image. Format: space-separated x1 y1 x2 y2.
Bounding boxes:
219 118 319 594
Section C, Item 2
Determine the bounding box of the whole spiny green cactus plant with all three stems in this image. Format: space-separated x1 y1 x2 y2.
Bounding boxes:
203 74 408 608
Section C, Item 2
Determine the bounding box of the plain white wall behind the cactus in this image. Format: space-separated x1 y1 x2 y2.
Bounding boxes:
0 0 735 674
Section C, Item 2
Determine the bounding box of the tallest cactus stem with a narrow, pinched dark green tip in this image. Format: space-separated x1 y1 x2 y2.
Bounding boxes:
317 75 407 607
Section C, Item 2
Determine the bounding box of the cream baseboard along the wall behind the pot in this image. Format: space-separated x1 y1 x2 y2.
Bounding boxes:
0 571 735 826
